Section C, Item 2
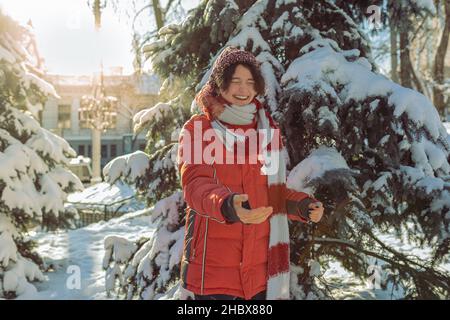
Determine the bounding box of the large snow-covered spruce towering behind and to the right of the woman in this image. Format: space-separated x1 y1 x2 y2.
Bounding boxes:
103 0 450 299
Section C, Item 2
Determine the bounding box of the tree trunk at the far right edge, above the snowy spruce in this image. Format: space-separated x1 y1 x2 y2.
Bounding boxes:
433 0 450 116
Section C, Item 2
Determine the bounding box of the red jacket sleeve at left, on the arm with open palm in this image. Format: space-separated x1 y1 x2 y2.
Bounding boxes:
177 118 232 223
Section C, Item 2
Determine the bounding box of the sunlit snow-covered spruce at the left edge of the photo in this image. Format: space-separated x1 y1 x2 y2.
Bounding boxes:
0 12 82 299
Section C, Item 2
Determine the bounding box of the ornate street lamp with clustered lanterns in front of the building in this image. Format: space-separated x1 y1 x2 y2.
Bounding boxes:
79 69 117 184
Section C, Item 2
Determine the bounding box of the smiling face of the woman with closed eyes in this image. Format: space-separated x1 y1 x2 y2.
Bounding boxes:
220 64 257 106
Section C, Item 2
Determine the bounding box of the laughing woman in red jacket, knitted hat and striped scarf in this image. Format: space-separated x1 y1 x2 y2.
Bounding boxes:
178 47 323 299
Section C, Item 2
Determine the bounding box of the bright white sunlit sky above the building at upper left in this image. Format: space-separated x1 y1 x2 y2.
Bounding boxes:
0 0 198 75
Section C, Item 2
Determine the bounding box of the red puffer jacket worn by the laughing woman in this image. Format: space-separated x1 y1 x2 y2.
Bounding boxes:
178 111 315 299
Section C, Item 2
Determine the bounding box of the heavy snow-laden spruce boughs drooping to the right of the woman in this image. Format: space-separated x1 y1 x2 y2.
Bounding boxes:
278 46 450 298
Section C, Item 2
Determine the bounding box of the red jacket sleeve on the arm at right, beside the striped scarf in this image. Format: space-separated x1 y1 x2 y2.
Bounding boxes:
285 188 318 223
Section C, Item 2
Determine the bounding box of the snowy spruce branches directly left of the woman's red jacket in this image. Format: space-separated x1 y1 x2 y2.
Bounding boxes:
103 98 192 299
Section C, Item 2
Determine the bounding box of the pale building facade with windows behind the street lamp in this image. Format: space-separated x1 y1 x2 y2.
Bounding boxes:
40 69 160 168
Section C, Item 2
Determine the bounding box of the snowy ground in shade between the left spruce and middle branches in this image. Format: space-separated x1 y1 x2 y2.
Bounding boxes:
26 209 154 299
